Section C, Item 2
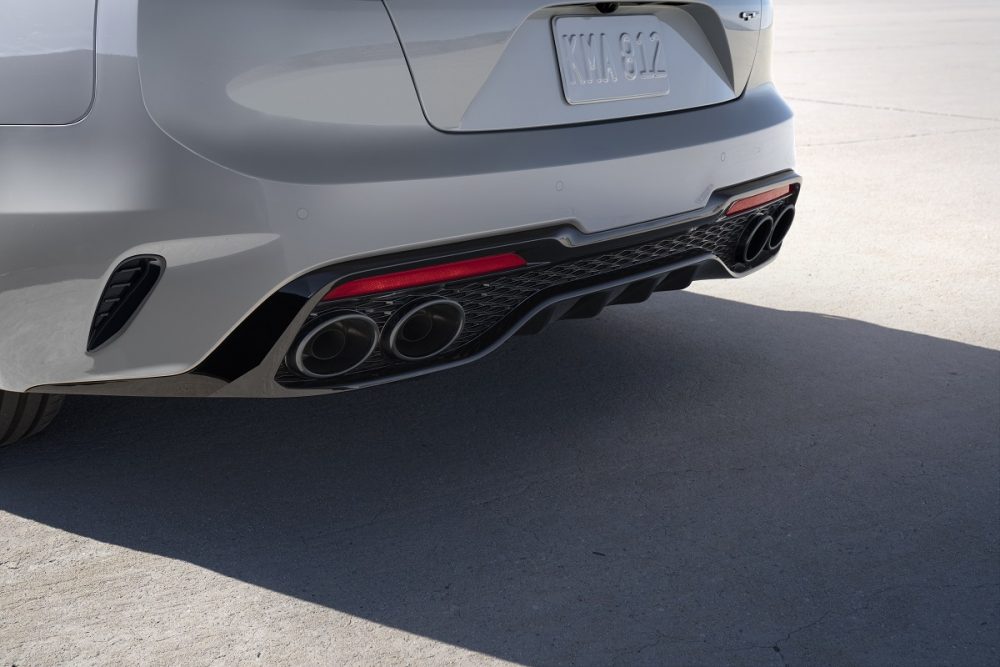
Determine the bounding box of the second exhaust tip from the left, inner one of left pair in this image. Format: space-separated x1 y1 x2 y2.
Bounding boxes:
385 299 465 361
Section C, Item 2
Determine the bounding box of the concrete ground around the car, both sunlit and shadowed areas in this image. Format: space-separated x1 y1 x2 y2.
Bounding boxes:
0 0 1000 666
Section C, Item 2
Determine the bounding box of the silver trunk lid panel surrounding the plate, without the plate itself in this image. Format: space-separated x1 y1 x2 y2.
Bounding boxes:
378 0 763 131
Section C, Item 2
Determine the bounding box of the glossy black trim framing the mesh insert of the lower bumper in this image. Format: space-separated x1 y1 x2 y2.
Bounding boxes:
30 171 801 397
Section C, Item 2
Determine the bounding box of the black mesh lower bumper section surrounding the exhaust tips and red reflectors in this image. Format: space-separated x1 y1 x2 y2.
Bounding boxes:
34 172 801 397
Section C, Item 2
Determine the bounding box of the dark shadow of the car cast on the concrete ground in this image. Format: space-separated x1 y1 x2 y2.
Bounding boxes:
0 294 1000 664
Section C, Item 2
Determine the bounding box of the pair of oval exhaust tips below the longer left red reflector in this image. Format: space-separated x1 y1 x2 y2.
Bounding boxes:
288 299 465 379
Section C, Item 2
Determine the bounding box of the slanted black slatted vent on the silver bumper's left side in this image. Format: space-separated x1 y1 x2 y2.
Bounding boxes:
87 255 166 352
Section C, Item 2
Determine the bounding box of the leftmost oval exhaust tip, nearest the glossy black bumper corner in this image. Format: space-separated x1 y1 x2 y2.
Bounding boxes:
289 313 379 380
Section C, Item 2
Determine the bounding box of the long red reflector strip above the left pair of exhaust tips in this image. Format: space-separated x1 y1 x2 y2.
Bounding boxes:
323 252 528 301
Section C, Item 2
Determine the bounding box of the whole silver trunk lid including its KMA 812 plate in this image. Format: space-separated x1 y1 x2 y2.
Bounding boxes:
384 0 762 132
